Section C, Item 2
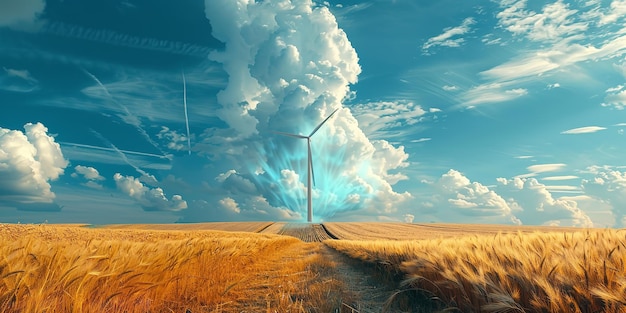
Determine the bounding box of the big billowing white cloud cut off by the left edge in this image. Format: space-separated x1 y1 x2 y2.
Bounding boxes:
0 123 68 211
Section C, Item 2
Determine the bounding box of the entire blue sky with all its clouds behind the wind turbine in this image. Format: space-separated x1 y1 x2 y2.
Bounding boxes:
0 0 626 227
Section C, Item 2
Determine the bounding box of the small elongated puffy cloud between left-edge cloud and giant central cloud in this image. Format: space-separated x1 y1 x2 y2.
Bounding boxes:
113 173 187 211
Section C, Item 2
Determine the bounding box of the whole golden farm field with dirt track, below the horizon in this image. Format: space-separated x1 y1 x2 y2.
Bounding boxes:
0 222 626 313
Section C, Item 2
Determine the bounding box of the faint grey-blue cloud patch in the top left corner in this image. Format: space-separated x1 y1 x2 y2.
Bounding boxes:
0 0 46 29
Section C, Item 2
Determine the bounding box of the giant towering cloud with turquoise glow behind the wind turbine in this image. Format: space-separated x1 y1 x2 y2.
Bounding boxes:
202 0 411 219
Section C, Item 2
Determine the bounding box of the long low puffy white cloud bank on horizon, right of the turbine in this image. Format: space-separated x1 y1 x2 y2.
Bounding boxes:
422 169 593 227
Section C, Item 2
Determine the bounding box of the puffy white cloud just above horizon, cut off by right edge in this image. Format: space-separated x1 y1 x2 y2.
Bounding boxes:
582 167 626 228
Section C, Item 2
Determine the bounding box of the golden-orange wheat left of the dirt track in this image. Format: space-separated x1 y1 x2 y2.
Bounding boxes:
0 224 342 312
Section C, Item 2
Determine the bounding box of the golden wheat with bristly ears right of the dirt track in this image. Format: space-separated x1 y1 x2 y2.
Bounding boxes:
325 230 626 312
